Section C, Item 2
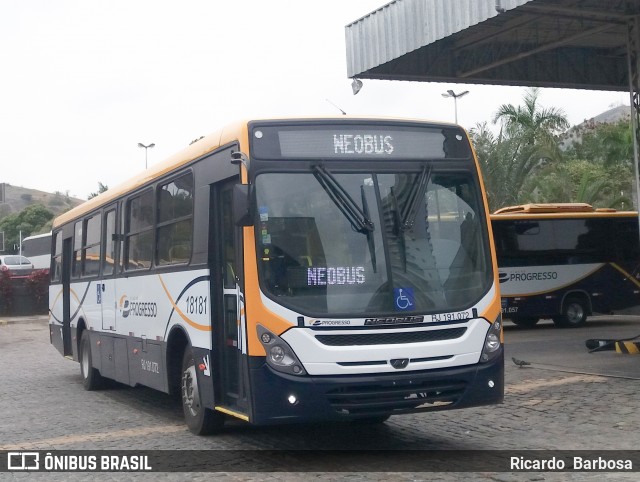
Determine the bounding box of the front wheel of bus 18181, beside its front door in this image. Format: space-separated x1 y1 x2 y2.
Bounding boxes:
180 347 224 435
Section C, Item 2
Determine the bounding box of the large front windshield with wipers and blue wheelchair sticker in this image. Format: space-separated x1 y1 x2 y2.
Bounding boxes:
255 167 492 317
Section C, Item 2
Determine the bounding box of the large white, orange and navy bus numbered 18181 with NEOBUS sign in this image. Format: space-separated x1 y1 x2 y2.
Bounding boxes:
50 116 504 434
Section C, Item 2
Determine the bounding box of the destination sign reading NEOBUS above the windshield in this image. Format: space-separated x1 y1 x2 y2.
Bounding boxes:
252 125 470 160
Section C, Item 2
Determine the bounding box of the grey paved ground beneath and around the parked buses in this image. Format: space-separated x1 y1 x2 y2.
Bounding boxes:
0 317 640 481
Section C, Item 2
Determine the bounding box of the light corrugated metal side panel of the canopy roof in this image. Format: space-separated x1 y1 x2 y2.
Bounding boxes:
346 0 532 77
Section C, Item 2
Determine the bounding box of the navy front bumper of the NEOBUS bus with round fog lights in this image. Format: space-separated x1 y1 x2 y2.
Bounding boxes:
250 349 504 425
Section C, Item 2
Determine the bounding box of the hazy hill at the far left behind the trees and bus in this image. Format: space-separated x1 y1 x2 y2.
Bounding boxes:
0 183 84 223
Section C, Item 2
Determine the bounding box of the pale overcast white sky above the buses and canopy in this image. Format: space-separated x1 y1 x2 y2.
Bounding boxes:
0 0 629 199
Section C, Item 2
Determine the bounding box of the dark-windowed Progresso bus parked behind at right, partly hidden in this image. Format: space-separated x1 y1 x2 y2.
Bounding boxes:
491 203 640 327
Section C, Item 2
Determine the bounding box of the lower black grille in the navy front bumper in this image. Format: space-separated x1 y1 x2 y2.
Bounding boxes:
327 380 467 416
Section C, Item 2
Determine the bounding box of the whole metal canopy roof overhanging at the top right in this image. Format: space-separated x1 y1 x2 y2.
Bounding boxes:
346 0 640 91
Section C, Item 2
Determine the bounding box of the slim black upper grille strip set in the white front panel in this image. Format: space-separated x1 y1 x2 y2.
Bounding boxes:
316 327 467 346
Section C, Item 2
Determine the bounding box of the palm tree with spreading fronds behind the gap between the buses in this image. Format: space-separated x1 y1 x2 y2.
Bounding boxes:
470 88 569 211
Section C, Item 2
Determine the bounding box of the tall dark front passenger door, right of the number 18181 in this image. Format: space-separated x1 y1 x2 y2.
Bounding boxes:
209 178 248 413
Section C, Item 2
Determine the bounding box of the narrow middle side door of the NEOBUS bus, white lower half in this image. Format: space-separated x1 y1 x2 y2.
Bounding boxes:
97 205 119 331
